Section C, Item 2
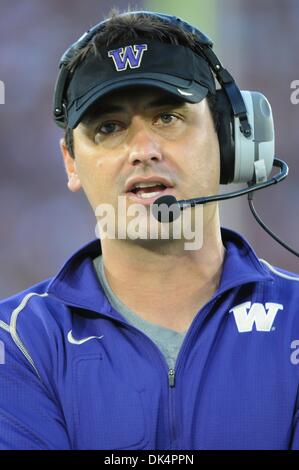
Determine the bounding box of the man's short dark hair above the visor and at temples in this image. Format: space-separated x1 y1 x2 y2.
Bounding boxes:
65 8 218 158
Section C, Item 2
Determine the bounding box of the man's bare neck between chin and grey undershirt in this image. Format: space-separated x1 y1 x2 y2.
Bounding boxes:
102 210 225 331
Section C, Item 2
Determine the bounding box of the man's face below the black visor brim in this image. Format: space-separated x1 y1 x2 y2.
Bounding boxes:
62 87 220 241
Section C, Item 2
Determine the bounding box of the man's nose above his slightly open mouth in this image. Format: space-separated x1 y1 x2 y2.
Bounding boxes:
129 122 162 166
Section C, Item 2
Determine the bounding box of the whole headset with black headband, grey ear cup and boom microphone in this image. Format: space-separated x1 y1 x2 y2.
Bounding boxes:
53 10 299 256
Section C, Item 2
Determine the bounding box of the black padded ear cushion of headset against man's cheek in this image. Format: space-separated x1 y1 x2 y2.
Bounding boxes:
216 89 235 184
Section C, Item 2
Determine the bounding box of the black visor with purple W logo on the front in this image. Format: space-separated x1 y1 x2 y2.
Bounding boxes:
66 38 216 129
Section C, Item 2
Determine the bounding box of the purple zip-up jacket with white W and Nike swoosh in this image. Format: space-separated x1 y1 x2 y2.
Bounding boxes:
0 229 299 450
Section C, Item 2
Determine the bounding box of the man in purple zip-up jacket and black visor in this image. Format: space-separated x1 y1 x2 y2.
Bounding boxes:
0 8 299 450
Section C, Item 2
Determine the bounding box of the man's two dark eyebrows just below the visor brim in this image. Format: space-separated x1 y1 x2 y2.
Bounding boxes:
82 96 187 125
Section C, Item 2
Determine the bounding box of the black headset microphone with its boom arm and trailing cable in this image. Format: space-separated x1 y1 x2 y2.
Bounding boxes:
152 158 299 257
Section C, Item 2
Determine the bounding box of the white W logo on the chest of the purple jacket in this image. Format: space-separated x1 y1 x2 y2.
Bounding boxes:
229 302 283 333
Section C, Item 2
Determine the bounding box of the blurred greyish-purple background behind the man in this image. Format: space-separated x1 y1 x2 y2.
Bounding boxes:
0 0 299 298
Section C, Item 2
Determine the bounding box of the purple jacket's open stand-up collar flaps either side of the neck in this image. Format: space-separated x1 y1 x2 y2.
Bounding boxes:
47 228 273 317
